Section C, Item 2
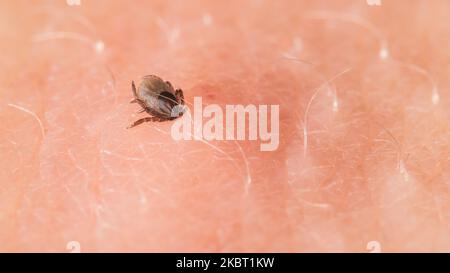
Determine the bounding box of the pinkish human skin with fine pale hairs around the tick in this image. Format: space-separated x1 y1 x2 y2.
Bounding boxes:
0 0 450 252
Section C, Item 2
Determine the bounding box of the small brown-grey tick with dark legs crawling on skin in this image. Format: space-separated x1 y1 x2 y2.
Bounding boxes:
127 75 184 128
